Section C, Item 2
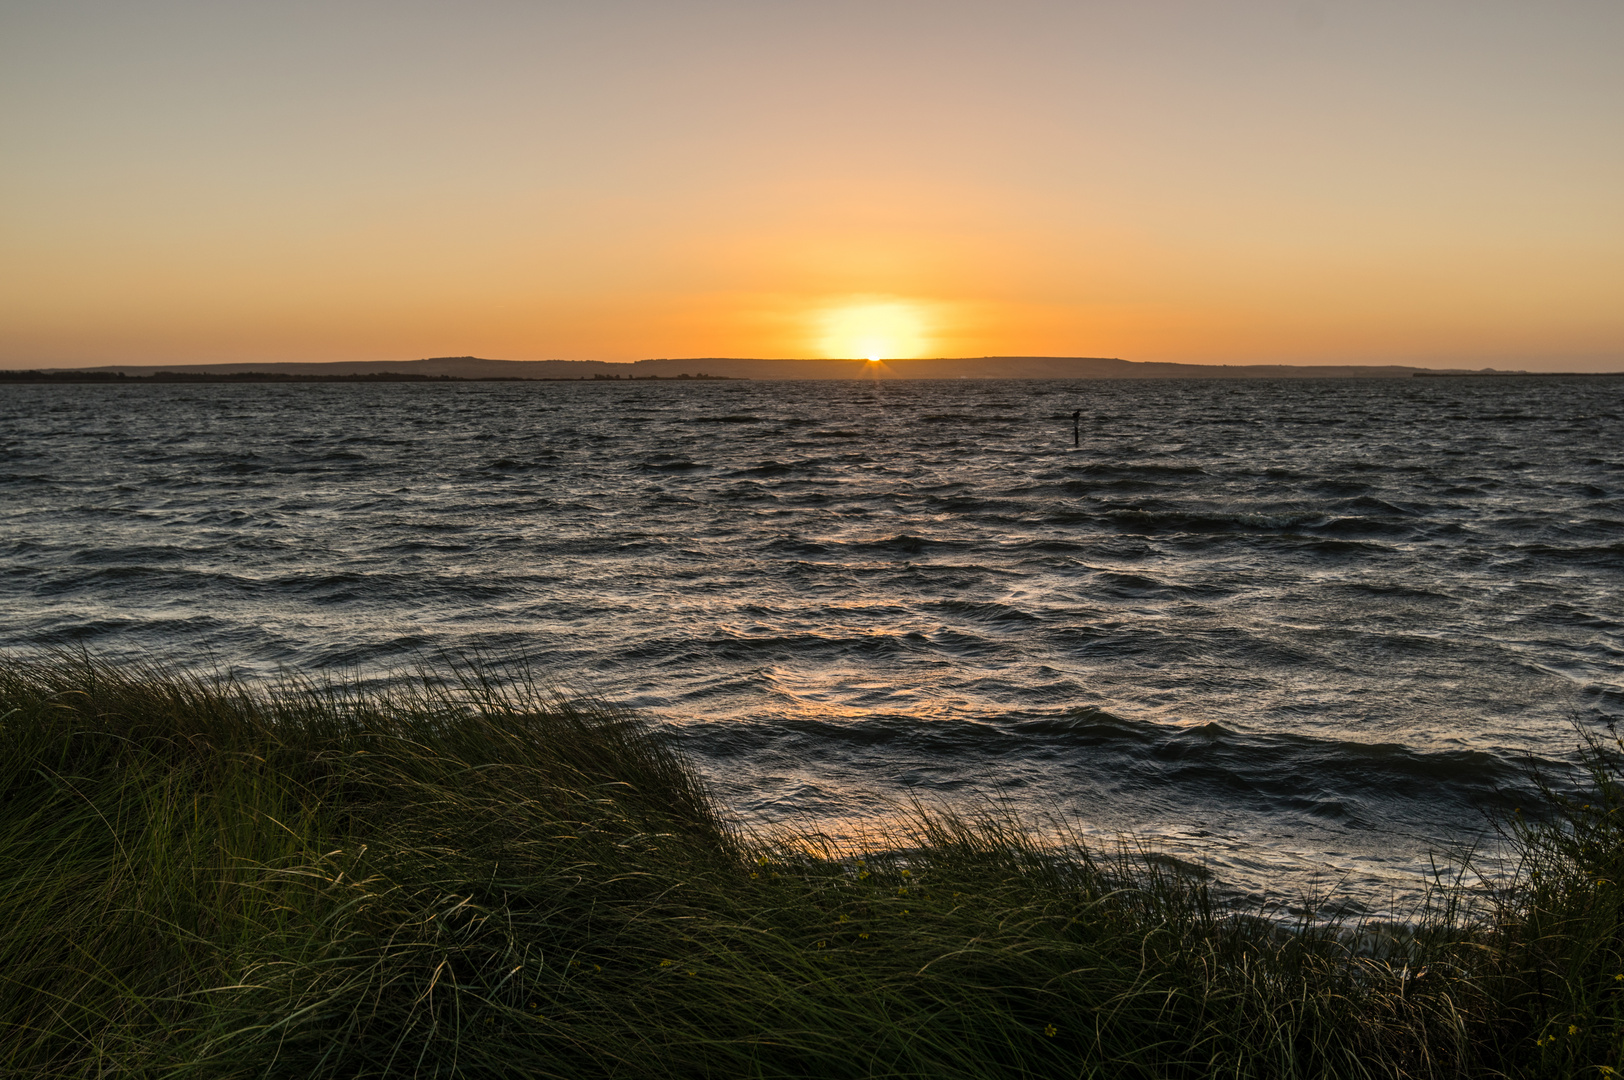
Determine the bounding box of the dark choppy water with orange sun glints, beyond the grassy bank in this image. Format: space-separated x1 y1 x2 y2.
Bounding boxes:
0 378 1624 906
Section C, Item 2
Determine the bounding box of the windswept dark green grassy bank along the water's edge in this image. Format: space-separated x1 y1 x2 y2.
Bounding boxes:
0 658 1624 1078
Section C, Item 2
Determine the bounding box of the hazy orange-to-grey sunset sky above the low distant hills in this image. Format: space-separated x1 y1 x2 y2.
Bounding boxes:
0 0 1624 370
